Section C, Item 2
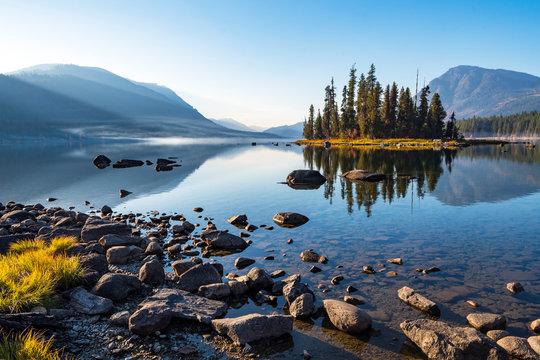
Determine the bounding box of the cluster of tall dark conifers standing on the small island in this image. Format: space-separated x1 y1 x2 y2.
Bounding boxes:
303 64 460 140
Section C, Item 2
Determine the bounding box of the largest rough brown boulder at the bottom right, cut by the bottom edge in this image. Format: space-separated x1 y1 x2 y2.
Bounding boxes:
400 319 508 360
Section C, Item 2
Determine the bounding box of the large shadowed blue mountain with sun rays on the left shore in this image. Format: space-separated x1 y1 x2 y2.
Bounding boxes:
0 64 270 139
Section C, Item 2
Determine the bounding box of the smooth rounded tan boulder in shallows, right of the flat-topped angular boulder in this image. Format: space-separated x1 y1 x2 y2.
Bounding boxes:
323 300 371 334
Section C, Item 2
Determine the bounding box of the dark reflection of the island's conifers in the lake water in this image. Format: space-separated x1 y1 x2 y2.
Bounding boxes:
304 146 457 217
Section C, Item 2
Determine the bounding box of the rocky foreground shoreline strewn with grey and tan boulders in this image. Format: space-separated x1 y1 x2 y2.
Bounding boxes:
0 195 540 359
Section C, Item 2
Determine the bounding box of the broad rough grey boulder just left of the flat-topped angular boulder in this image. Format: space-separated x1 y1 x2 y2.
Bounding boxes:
129 289 227 335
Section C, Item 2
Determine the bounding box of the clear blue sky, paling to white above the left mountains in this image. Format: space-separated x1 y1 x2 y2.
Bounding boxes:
0 0 540 127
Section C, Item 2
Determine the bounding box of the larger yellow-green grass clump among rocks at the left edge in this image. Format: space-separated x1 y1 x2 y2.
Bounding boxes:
0 237 83 312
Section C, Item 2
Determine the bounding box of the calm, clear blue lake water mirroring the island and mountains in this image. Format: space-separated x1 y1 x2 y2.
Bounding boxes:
0 144 540 359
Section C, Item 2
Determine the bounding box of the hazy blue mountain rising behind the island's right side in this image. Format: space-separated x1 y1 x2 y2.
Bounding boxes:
429 65 540 119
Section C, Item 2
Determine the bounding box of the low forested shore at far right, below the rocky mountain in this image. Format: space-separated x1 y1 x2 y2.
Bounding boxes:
457 111 540 136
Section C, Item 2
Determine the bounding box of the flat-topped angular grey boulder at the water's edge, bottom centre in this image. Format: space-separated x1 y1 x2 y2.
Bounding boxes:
212 314 293 345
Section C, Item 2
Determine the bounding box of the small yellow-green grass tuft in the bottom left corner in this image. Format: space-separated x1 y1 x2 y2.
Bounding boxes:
0 330 62 360
